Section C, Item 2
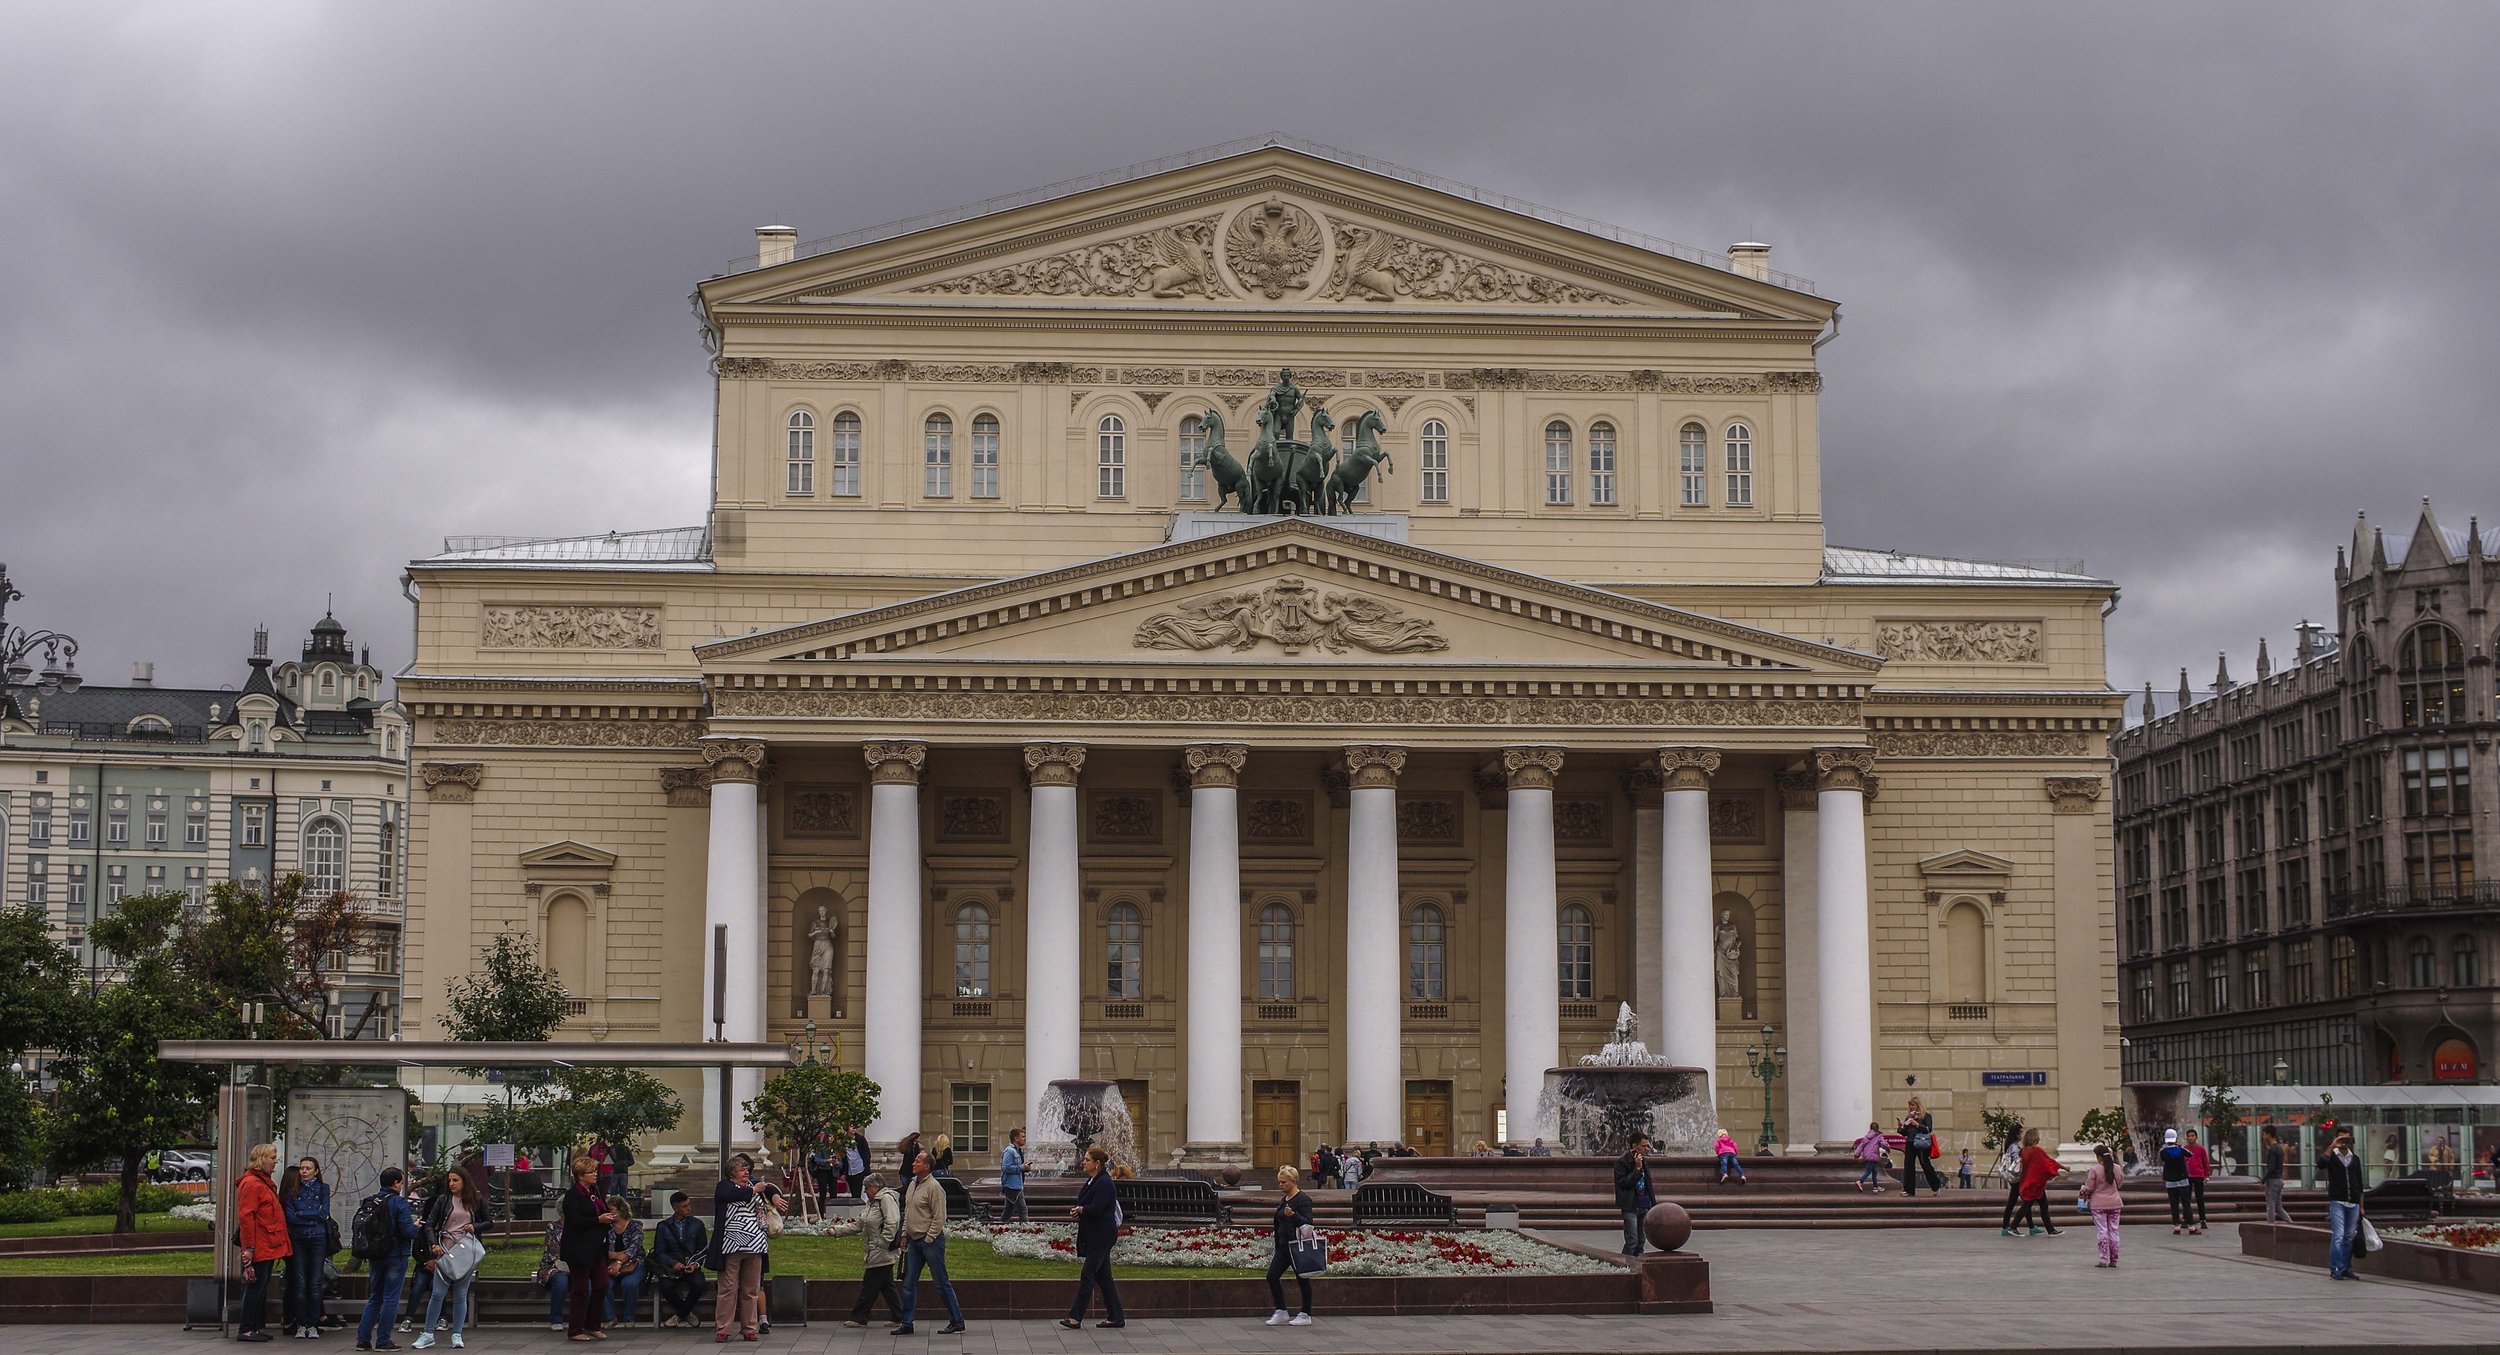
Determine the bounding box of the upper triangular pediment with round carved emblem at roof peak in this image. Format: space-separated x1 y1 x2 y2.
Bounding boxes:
703 145 1833 323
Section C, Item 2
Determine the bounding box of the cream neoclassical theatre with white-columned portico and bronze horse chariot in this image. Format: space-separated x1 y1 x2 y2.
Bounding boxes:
400 143 2120 1165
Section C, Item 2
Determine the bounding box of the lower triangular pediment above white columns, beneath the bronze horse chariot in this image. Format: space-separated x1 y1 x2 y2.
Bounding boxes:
698 518 1880 685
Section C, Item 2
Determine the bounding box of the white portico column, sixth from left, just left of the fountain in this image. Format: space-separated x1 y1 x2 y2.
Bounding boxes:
1503 748 1563 1155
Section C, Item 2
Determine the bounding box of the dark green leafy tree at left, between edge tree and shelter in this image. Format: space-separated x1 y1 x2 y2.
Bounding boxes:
50 890 235 1233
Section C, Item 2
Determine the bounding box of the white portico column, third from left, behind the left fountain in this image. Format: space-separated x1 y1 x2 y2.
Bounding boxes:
1025 743 1085 1140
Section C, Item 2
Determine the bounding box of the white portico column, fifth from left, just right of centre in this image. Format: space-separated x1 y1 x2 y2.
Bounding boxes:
1343 745 1405 1143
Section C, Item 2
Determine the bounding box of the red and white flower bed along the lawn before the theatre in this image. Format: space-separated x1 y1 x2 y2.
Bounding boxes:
985 1223 1618 1278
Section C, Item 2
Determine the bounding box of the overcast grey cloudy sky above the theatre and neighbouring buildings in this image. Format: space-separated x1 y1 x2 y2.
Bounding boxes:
0 0 2500 688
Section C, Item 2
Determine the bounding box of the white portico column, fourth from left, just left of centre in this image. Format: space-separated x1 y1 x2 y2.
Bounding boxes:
1180 743 1250 1168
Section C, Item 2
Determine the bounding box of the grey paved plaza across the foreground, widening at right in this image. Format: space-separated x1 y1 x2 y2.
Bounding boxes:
0 1228 2500 1355
